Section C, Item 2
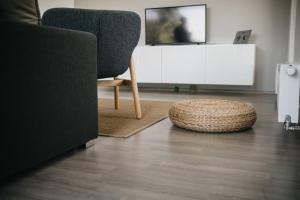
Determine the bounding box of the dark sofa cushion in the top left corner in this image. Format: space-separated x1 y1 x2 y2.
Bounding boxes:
0 0 41 24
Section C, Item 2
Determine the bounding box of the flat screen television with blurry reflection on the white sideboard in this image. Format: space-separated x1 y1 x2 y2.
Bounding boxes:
145 4 206 45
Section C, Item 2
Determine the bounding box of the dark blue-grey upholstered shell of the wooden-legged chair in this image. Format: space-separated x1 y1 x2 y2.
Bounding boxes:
42 8 141 79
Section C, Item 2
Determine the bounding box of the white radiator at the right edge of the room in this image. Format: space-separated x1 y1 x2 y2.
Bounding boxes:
276 64 300 123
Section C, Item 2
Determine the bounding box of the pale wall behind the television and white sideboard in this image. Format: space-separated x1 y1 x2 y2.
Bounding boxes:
75 0 291 92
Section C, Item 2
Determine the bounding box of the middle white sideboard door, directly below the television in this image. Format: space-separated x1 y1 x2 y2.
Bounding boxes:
162 45 205 84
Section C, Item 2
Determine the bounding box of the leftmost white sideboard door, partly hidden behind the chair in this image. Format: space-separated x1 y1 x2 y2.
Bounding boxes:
120 46 162 83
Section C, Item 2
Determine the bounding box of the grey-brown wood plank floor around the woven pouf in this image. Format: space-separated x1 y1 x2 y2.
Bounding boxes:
0 93 300 200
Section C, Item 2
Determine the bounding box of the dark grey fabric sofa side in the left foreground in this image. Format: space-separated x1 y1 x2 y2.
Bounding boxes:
0 22 98 179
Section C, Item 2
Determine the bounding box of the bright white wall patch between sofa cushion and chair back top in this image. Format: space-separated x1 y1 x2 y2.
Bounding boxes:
39 0 74 15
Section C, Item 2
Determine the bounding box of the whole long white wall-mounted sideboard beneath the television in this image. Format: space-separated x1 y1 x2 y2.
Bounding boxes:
120 44 255 86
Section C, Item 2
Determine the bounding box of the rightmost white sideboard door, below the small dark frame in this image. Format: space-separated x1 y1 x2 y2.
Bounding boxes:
206 44 255 85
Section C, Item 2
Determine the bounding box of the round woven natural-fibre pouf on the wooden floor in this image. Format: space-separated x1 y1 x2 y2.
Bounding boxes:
169 99 256 133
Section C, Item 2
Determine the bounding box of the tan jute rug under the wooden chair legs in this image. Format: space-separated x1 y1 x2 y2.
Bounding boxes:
98 99 172 138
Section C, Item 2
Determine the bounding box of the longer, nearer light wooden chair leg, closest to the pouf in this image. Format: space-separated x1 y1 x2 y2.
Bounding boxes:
129 59 142 119
